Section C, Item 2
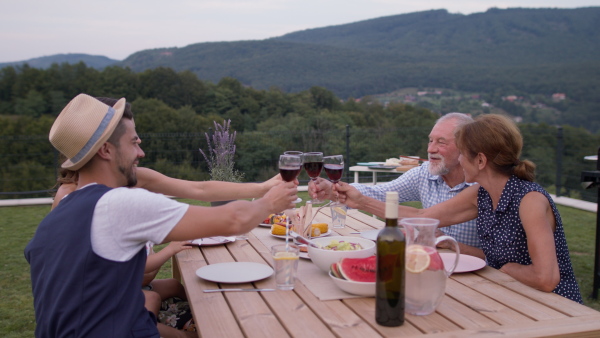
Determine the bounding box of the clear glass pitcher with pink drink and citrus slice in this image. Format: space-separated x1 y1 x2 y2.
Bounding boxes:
400 218 460 315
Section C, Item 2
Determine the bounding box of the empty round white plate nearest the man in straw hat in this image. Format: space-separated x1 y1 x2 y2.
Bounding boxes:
196 262 273 283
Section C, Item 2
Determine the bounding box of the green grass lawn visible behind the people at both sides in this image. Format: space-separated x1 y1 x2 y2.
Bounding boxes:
0 193 600 337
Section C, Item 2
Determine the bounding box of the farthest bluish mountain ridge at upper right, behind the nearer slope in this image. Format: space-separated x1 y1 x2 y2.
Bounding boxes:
276 7 600 65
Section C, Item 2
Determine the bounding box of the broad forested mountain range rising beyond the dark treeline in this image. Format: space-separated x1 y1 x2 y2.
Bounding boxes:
118 7 600 98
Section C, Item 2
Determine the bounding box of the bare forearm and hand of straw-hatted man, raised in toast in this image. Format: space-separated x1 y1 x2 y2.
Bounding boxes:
163 182 297 243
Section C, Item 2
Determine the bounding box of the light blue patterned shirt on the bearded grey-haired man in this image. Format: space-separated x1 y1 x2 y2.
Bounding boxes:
351 162 481 248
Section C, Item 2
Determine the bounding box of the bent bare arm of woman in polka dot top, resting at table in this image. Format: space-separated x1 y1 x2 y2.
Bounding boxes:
500 192 560 292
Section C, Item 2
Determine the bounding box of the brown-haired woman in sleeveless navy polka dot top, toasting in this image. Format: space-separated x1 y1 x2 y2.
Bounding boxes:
336 114 582 303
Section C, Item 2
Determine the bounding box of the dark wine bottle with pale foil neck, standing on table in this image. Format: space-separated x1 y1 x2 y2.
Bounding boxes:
375 191 406 326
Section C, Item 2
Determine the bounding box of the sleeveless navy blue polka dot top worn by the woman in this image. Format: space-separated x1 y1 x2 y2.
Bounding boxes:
477 175 583 303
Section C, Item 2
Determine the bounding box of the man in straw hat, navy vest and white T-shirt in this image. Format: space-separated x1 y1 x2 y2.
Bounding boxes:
25 94 296 337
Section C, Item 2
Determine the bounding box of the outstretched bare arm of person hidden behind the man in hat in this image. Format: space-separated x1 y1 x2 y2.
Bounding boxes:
136 168 282 202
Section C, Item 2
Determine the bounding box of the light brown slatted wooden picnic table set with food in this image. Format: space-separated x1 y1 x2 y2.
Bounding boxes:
173 208 600 338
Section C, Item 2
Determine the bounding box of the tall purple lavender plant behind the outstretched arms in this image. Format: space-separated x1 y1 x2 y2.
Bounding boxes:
199 120 244 182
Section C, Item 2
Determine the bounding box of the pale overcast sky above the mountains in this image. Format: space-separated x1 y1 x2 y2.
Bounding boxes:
0 0 600 62
